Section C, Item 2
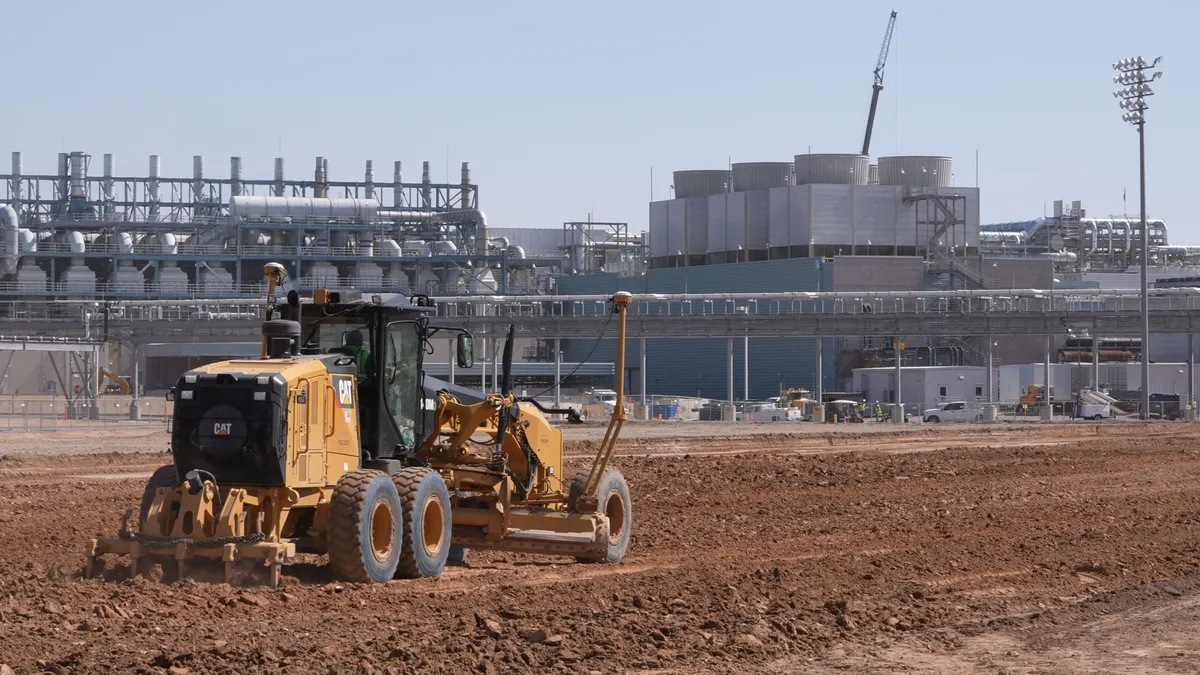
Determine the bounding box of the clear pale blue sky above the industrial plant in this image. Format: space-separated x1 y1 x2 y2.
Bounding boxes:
0 0 1200 237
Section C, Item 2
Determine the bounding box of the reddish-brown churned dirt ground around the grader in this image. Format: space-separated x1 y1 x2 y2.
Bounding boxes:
0 423 1200 675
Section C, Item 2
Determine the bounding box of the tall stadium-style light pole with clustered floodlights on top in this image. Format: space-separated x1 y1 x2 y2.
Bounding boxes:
1112 56 1163 419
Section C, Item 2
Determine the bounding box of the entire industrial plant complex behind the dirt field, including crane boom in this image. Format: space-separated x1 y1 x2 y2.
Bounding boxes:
0 12 1200 418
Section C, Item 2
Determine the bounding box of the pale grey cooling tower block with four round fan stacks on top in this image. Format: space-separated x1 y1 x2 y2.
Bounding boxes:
649 155 979 268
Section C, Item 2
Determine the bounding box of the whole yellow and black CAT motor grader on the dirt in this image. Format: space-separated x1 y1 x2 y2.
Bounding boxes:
85 263 632 586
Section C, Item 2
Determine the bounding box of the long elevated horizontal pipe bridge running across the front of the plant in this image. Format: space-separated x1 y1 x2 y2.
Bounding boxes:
0 288 1200 342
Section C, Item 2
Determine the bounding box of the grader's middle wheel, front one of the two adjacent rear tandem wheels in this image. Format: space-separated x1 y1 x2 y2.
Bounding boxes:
391 466 450 579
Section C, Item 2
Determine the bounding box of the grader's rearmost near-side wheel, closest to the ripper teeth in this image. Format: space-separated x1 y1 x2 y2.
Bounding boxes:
326 470 402 584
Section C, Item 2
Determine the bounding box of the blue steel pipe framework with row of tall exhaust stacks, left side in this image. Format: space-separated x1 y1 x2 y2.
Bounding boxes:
0 151 643 299
